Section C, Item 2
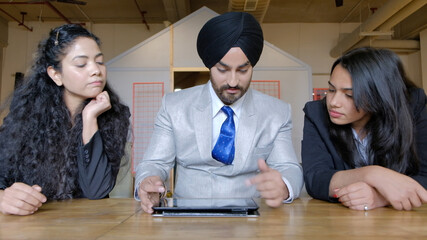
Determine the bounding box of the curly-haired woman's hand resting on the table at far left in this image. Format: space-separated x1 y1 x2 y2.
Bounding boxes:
0 182 47 215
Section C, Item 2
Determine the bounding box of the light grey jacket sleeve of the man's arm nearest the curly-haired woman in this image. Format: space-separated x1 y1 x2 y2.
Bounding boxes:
134 95 176 201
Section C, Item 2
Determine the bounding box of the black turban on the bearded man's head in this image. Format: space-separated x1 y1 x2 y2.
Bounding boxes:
197 12 264 69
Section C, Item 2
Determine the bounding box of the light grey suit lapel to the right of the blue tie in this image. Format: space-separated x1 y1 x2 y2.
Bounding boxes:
234 88 258 171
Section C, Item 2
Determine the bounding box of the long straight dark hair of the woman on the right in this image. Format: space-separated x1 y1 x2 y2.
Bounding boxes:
329 47 419 175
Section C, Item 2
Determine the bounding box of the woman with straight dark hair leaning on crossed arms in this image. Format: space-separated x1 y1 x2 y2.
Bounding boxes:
302 48 427 211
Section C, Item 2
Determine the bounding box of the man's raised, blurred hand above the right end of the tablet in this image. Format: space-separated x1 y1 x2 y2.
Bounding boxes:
248 159 289 207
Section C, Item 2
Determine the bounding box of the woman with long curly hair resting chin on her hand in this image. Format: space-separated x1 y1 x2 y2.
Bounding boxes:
0 24 130 215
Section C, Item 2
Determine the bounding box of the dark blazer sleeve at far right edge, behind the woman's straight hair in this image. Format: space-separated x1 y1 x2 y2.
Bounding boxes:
411 88 427 189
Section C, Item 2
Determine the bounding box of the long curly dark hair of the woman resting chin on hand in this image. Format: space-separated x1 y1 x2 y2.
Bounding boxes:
0 24 130 199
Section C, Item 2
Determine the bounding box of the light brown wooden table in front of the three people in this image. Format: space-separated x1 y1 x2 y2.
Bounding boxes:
0 198 427 240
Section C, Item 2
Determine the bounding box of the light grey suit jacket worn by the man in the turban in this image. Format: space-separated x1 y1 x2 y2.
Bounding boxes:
135 84 303 198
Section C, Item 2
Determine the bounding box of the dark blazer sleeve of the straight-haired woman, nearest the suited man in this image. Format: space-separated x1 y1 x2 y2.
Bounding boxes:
301 102 343 202
